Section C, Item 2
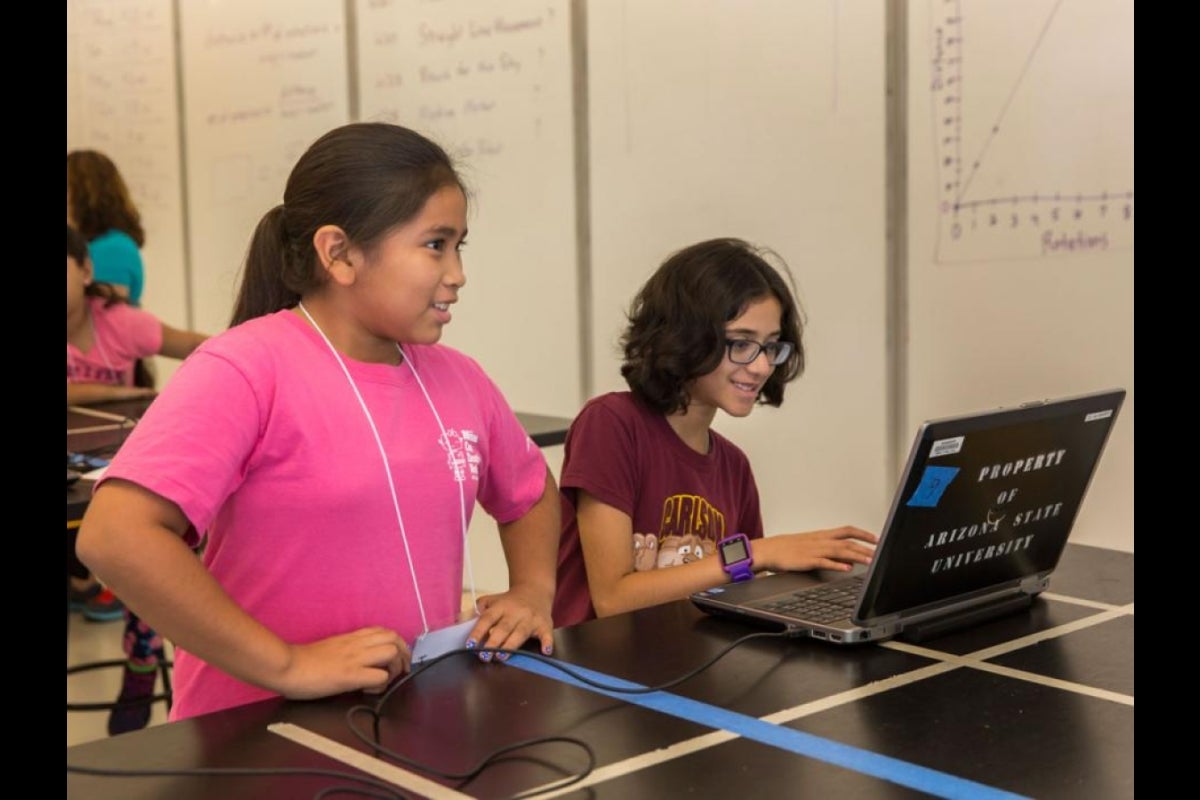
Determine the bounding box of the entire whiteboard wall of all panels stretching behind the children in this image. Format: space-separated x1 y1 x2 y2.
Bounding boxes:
67 0 1134 563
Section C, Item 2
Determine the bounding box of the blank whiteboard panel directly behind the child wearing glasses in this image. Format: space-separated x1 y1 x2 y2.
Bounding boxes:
587 0 892 533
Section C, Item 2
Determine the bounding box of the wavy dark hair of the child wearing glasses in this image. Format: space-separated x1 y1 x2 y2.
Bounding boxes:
620 237 804 414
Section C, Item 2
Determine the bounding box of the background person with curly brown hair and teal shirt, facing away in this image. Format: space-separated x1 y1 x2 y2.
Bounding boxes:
67 150 145 306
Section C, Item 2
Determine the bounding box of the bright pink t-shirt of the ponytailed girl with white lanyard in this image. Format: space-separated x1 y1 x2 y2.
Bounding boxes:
104 311 546 720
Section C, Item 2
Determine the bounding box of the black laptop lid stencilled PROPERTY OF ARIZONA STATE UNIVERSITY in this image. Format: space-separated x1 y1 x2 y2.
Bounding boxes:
858 390 1126 620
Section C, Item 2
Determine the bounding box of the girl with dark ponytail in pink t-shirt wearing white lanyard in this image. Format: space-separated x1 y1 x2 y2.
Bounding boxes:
77 122 559 720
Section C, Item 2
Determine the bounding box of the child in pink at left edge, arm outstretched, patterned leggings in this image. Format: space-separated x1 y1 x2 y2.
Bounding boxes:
67 225 206 734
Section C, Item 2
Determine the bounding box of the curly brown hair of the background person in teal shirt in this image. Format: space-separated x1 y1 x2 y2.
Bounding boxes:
67 150 146 247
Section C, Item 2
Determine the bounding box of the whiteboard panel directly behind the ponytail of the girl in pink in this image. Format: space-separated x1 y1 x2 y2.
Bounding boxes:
179 0 349 332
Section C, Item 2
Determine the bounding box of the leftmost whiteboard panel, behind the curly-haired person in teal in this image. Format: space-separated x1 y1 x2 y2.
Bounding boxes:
67 0 190 386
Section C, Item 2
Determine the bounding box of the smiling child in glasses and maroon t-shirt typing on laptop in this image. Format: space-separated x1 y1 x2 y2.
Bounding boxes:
554 239 877 626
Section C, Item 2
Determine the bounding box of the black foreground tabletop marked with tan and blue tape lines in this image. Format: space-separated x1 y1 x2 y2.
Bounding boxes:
67 545 1134 800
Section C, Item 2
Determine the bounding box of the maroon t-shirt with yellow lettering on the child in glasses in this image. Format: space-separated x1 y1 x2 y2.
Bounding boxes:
554 392 762 627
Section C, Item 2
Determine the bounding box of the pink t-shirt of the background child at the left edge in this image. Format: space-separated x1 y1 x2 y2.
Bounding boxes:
67 297 162 386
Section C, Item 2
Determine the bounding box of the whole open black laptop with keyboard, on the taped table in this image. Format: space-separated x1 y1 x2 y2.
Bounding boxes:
691 389 1126 644
